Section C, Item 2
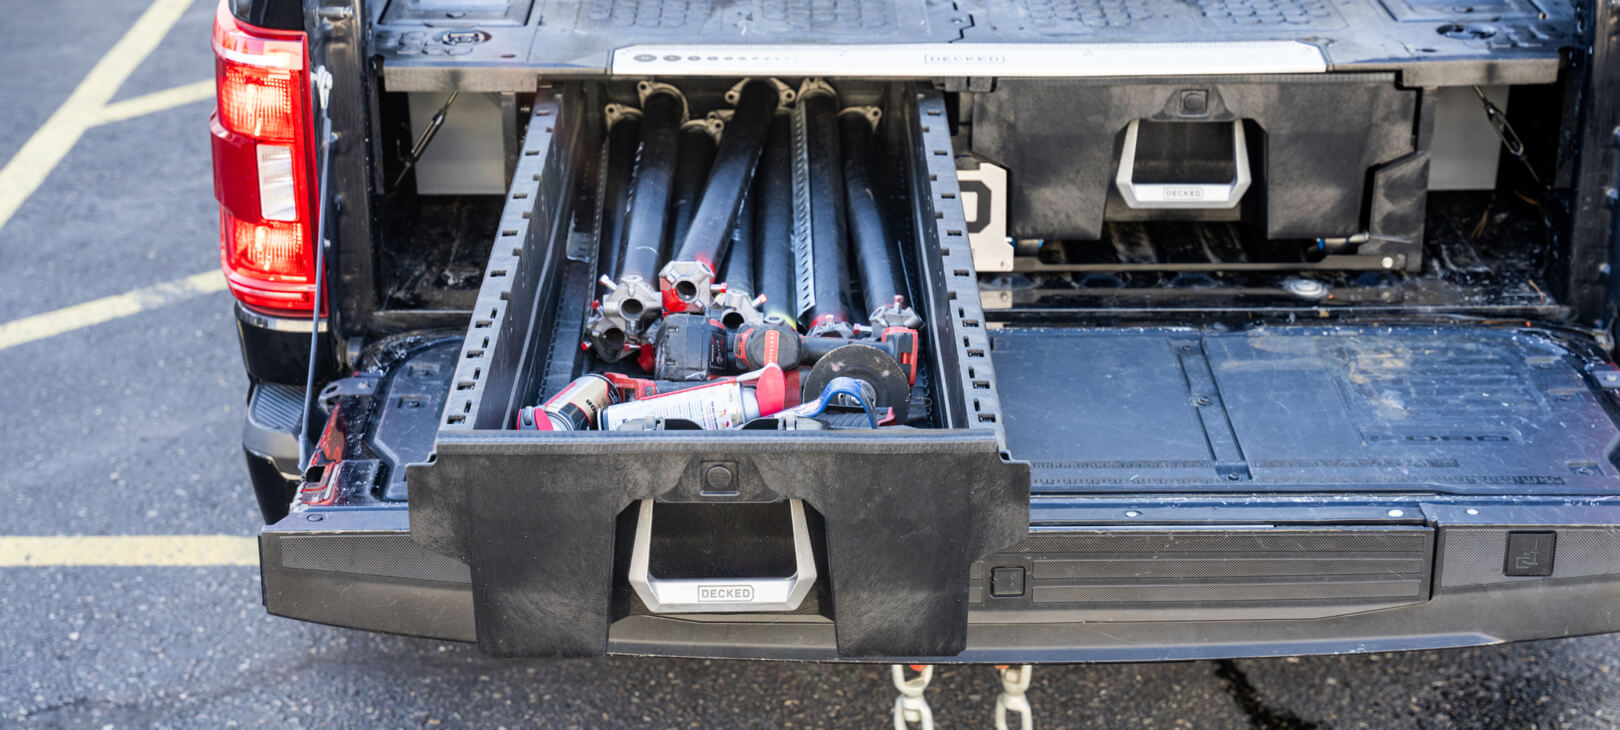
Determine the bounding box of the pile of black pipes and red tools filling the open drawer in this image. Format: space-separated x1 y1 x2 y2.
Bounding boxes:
517 78 923 431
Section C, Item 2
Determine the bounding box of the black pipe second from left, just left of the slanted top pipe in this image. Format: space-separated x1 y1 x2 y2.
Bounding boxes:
617 89 685 282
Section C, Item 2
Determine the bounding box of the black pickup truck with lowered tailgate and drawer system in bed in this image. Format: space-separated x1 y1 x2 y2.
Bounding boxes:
211 0 1620 664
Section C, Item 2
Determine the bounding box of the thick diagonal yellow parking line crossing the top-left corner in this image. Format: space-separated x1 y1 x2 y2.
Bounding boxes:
0 0 191 234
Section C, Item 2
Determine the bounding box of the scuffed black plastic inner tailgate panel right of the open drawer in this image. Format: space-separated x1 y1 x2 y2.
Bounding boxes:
991 327 1620 494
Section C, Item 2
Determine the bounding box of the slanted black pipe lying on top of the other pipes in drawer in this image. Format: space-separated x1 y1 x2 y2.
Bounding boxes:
671 79 781 273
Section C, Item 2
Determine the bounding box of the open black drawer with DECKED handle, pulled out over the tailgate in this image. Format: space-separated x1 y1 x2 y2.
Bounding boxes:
408 83 1029 656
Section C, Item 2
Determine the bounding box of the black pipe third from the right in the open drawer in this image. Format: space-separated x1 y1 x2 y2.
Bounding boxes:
750 113 799 327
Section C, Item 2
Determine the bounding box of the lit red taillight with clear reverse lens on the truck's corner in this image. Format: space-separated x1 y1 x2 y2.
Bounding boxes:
209 2 314 314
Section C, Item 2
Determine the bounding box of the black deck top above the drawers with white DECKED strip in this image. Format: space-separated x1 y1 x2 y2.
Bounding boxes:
373 0 1575 91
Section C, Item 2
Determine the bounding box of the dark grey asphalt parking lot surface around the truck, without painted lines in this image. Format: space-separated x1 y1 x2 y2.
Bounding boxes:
0 0 1620 728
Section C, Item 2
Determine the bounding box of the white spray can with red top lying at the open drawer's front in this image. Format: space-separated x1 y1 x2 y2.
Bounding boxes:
601 363 787 431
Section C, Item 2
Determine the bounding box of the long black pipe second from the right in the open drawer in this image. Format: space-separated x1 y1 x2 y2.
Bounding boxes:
794 89 849 333
